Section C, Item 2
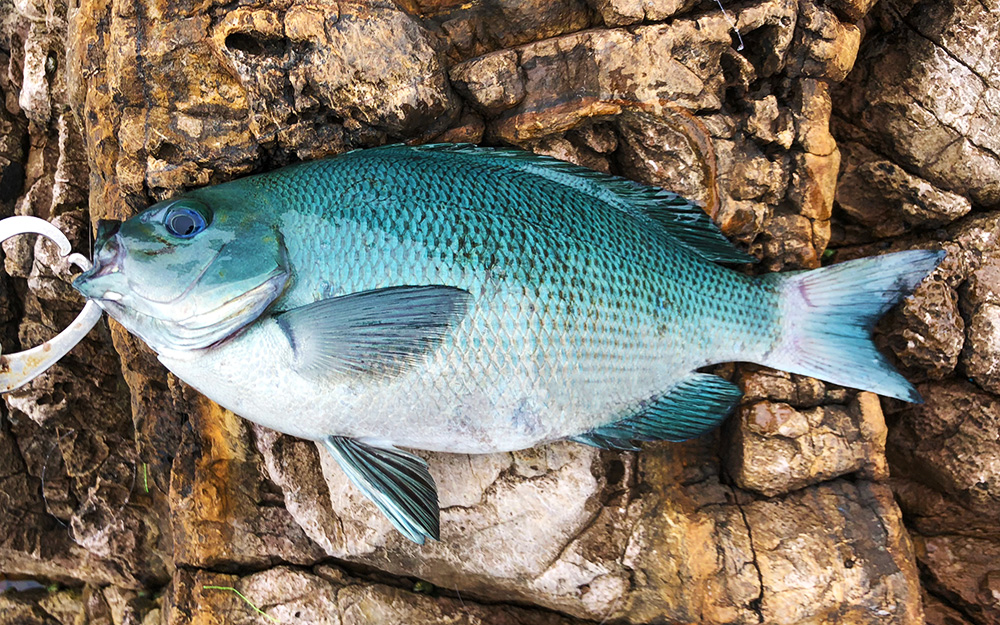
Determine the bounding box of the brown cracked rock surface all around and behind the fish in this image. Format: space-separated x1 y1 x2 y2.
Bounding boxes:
0 0 1000 625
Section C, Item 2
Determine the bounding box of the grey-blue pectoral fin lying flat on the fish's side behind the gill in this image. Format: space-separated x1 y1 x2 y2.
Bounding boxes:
276 286 471 377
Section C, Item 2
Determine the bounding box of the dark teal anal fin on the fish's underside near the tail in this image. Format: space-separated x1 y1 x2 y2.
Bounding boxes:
572 373 743 450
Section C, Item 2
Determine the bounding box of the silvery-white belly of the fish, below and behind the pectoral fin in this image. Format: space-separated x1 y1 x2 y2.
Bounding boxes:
160 260 768 453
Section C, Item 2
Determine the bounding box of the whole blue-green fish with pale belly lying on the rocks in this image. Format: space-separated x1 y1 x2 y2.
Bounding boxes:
74 145 943 542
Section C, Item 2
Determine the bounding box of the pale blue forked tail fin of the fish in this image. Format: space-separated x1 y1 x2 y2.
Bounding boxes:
763 250 945 402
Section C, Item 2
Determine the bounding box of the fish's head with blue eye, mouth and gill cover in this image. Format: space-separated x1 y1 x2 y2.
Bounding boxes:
73 185 290 353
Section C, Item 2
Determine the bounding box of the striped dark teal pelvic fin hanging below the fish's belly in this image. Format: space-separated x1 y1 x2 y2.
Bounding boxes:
323 436 441 545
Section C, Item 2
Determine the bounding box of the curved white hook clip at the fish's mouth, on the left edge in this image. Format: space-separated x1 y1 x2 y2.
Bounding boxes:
0 215 103 393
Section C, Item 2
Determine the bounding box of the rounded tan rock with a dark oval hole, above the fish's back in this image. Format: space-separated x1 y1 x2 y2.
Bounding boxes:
211 5 454 152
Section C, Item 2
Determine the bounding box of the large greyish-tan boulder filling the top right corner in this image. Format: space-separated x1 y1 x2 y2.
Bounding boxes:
839 0 1000 206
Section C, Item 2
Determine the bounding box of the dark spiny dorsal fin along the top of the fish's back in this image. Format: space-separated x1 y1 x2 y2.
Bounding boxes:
375 143 757 263
